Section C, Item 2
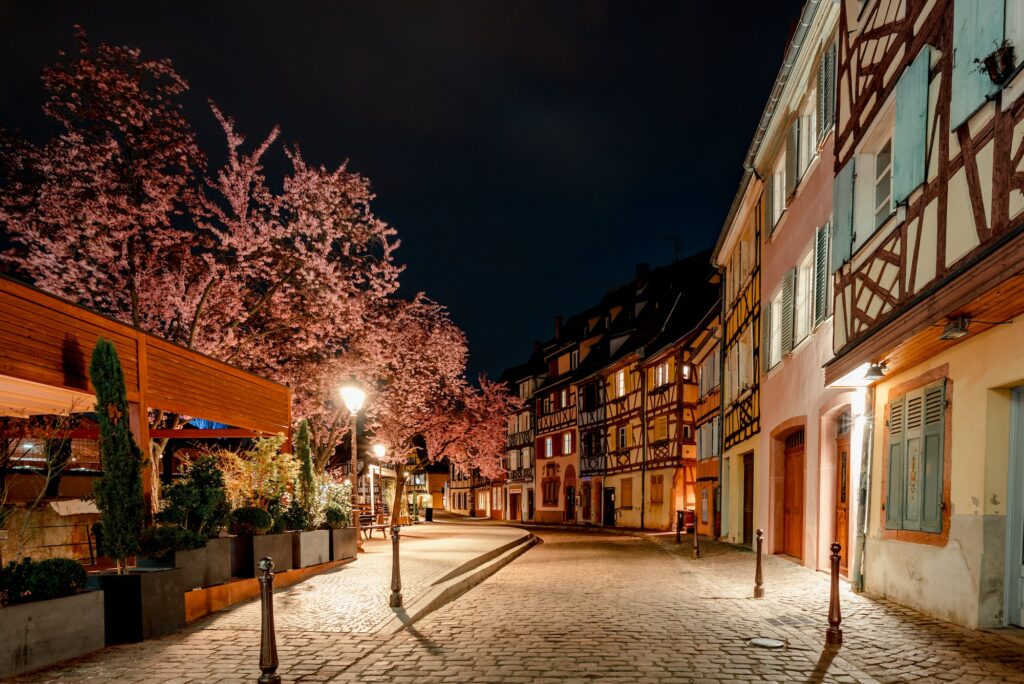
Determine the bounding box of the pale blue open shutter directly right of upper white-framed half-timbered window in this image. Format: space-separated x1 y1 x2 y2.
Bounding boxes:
893 45 932 204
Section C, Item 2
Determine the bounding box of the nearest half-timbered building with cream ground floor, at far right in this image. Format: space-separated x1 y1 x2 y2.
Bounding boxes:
825 0 1024 627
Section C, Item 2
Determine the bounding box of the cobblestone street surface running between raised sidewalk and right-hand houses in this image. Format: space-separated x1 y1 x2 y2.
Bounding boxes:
12 530 1024 684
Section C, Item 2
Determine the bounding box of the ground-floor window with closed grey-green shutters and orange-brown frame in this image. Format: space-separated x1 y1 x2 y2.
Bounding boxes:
885 380 946 532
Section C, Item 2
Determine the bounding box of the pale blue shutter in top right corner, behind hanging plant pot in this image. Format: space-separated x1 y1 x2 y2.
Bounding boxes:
949 0 1006 131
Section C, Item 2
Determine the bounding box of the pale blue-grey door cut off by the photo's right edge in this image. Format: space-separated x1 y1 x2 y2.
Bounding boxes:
1005 387 1024 627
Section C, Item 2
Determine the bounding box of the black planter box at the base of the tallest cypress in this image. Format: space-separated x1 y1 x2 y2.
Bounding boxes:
88 568 185 645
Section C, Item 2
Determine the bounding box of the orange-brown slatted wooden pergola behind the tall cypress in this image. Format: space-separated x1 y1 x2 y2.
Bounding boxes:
0 276 292 505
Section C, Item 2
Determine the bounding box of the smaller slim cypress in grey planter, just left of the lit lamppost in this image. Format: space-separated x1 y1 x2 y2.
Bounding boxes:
288 419 331 567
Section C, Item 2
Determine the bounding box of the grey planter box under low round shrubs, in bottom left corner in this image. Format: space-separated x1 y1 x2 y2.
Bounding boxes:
0 592 103 678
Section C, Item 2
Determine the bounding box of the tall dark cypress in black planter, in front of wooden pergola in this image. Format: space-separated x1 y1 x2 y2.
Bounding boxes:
89 338 185 644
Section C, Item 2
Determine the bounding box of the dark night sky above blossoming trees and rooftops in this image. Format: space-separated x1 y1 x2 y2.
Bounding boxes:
0 0 803 376
